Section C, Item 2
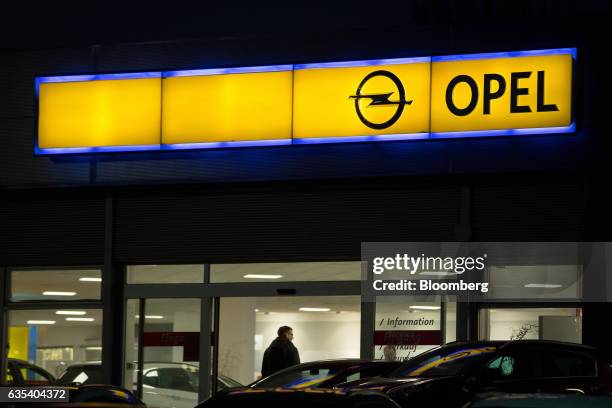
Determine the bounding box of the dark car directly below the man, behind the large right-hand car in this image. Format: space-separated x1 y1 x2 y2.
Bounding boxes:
249 359 402 388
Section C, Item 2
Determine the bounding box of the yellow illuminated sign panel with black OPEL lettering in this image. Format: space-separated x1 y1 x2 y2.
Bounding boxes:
431 54 573 132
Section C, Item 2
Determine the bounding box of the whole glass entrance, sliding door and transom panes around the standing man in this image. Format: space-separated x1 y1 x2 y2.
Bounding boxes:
124 261 364 400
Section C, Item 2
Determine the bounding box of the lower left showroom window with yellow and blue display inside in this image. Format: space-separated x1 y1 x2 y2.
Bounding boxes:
8 308 102 381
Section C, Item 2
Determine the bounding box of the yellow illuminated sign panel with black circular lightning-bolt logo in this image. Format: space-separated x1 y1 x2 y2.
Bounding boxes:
293 58 431 139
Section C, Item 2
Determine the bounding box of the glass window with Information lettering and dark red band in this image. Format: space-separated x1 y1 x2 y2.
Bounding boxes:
374 296 443 361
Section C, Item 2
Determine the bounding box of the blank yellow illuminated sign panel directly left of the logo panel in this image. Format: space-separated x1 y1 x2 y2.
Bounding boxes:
162 69 293 144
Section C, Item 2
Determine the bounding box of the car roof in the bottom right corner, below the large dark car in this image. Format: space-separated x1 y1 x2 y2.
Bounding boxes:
465 394 612 408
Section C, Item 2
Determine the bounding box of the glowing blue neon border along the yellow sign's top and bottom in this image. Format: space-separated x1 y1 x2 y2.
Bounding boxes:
34 48 577 155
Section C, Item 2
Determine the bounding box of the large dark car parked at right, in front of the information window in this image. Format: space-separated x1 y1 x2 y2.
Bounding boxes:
341 340 612 407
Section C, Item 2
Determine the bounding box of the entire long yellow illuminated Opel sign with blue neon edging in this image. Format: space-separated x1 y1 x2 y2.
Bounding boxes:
36 49 576 154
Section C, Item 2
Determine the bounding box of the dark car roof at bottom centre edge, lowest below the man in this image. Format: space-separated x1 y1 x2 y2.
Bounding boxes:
196 388 399 408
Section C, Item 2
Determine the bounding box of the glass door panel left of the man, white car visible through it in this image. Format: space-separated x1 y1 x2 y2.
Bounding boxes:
124 299 201 408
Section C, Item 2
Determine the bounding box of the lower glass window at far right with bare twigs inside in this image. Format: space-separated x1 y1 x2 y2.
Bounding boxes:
480 308 582 343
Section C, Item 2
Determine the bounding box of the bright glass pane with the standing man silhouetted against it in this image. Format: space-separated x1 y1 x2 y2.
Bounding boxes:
218 296 361 384
